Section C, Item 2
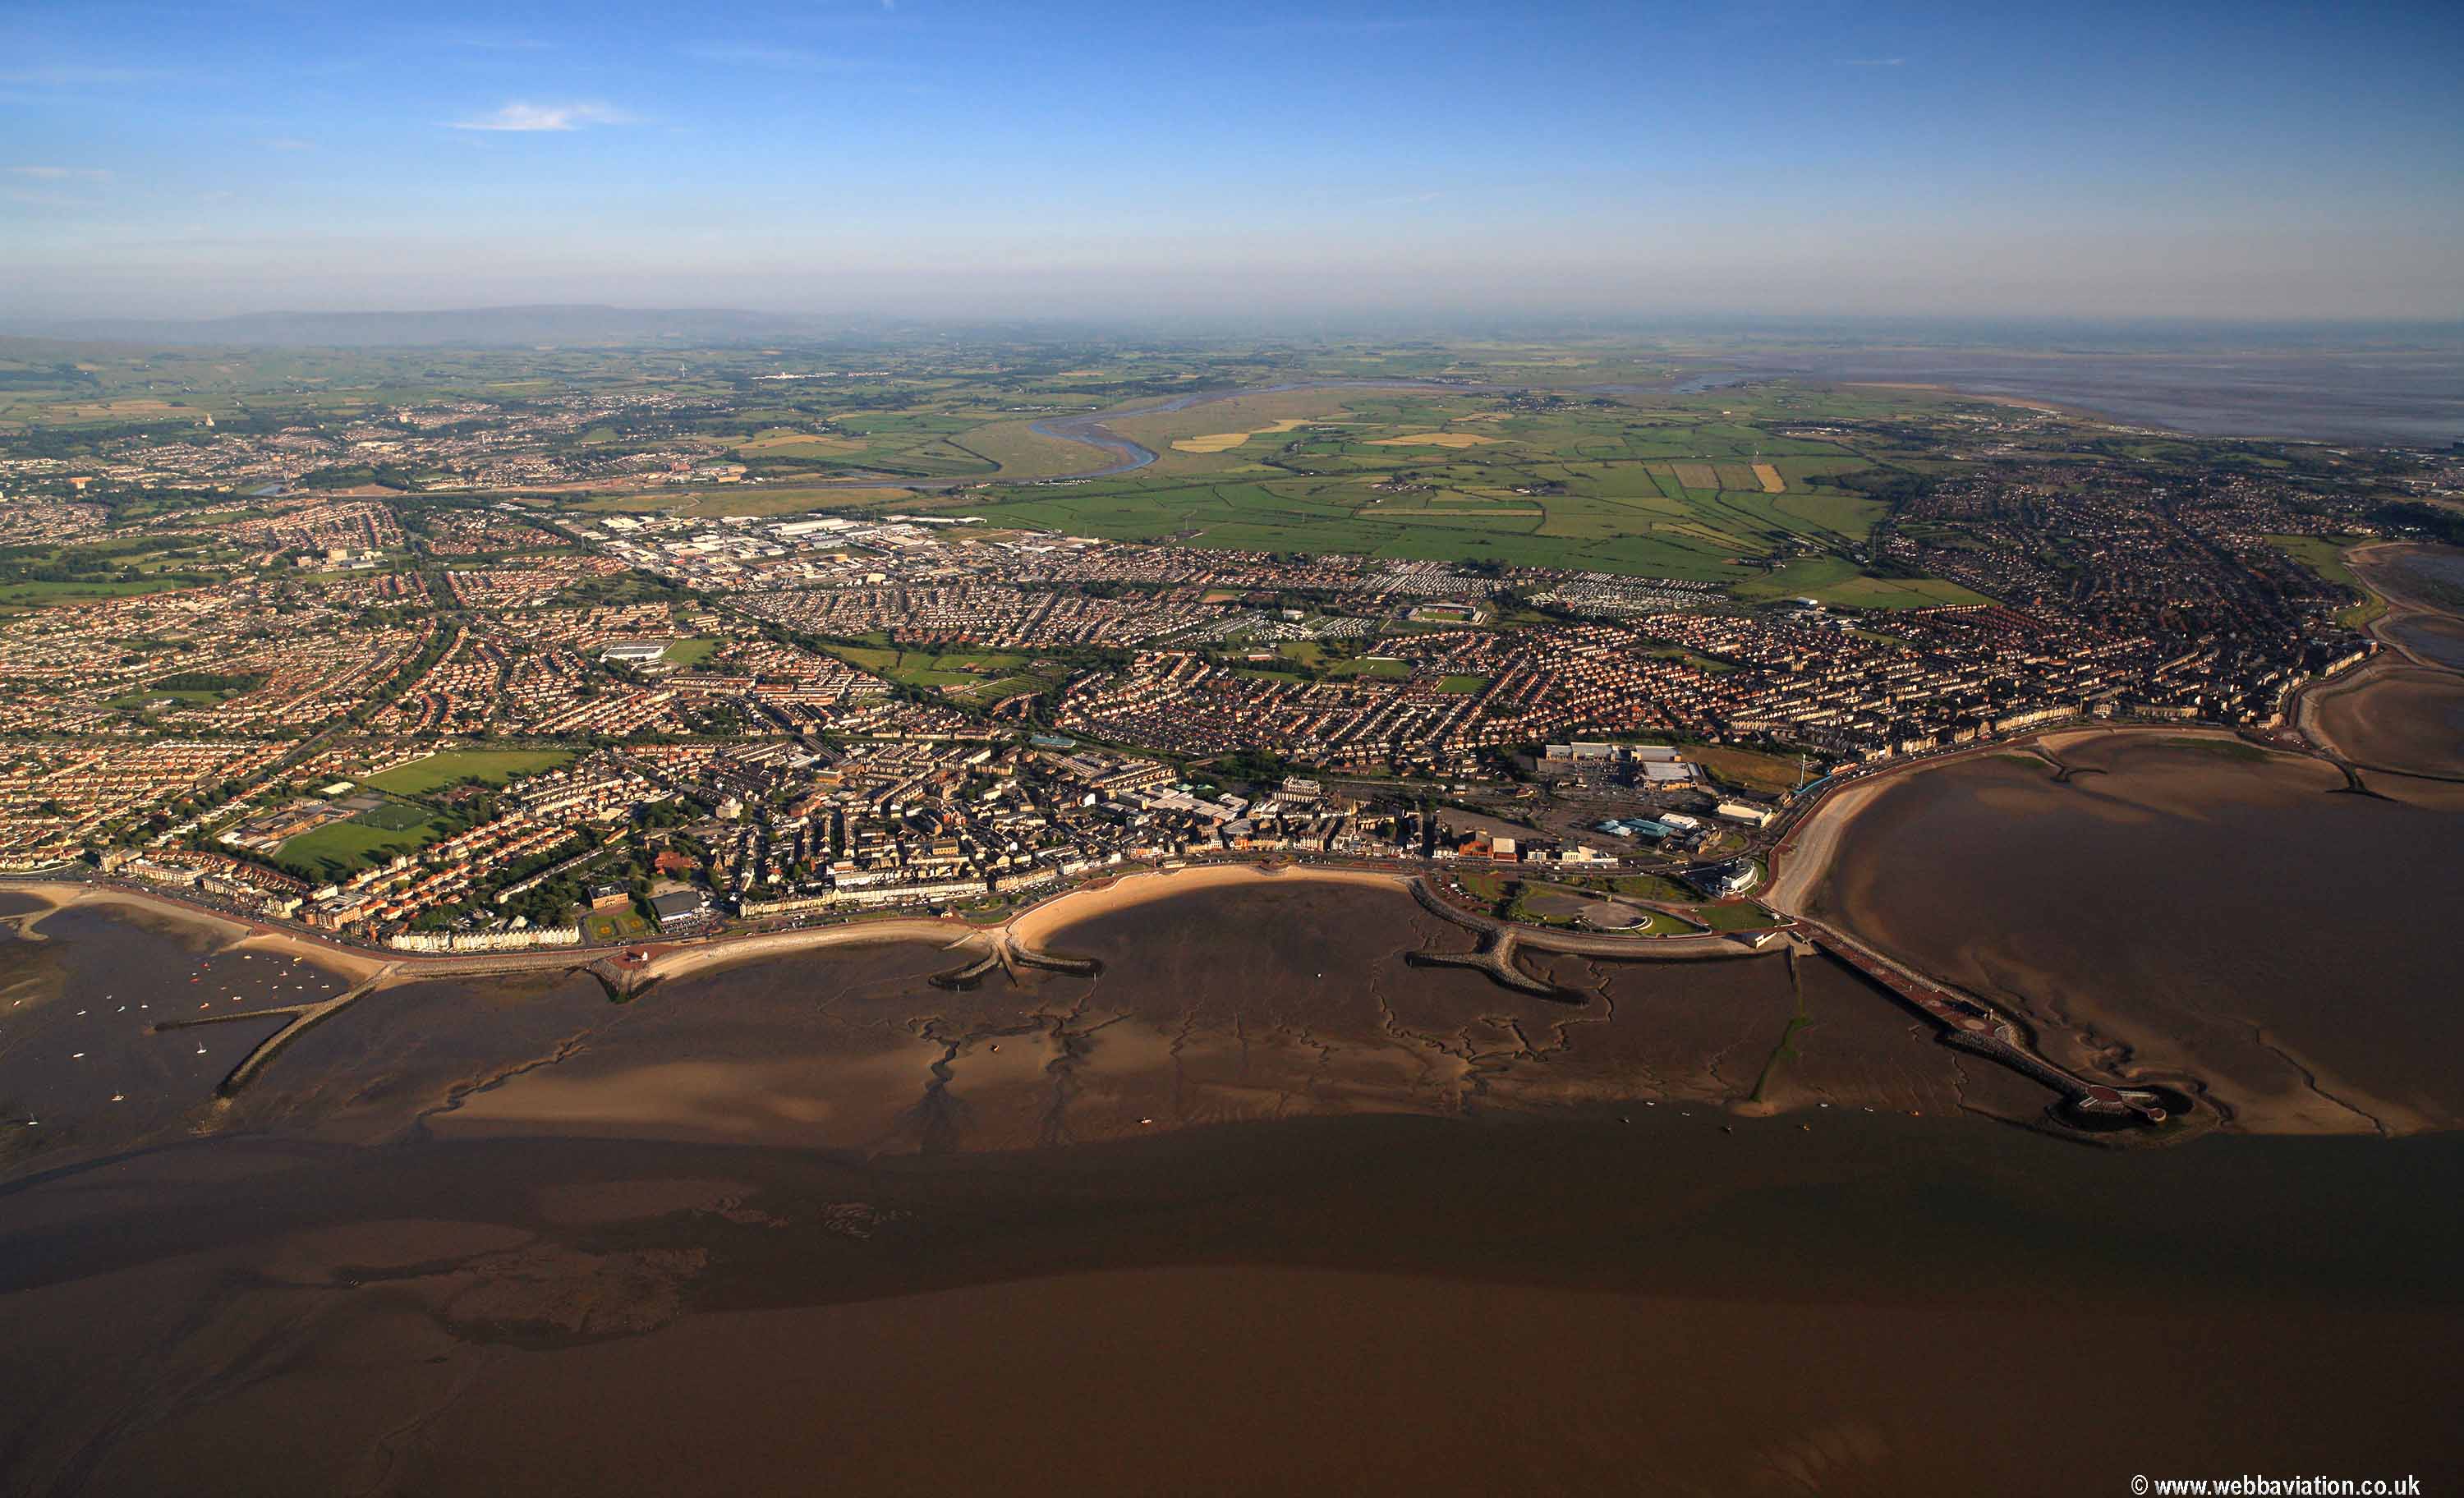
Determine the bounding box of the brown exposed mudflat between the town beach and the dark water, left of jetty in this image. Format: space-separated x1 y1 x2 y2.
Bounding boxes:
384 870 2045 1156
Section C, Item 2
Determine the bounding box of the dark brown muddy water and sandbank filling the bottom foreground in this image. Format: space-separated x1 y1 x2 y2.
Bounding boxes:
0 1106 2464 1493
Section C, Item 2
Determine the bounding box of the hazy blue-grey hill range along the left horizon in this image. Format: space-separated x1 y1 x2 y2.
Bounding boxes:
0 306 813 347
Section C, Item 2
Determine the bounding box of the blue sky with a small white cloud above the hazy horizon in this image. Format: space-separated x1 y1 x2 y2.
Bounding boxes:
0 0 2464 318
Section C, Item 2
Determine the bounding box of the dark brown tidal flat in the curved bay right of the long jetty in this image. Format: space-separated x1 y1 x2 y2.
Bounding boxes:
1814 734 2464 1133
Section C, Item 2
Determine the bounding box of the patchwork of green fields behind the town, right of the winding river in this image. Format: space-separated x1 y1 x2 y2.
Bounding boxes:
887 387 1944 581
